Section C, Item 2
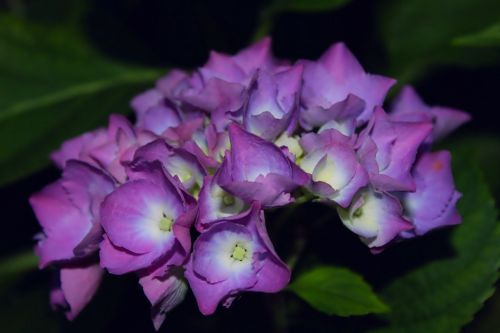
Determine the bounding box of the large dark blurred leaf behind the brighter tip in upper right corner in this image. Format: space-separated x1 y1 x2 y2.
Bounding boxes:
378 0 500 82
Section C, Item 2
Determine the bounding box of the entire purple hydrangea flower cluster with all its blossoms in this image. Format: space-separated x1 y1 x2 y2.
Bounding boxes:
30 39 469 328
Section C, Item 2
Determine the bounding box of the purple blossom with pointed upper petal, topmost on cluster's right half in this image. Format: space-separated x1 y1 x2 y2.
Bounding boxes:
300 43 395 131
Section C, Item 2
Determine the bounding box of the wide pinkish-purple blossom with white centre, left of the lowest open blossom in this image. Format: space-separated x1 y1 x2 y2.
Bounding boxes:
100 161 195 274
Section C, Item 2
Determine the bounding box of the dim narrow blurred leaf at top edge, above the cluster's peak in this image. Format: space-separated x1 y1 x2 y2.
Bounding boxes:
253 0 351 40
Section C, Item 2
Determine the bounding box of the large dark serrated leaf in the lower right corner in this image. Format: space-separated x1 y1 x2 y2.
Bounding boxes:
374 151 500 333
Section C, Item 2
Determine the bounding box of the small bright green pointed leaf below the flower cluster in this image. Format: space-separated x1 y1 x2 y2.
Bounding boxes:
288 266 389 316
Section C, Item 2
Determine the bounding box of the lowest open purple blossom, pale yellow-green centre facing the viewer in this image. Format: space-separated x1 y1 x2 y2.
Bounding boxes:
185 202 290 315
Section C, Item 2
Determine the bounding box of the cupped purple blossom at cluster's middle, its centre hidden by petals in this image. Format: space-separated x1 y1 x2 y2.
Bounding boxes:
217 124 309 207
